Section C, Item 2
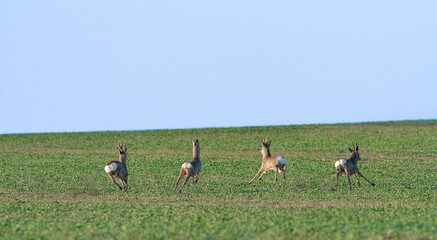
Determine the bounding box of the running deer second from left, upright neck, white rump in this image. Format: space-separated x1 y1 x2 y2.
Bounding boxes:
173 139 201 193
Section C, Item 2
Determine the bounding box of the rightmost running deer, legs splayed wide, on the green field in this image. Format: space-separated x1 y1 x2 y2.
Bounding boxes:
335 143 375 190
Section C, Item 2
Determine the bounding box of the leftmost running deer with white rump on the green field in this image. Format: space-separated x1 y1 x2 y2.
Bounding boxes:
105 144 129 197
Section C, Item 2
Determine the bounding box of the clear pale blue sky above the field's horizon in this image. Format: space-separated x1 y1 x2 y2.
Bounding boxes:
0 0 437 133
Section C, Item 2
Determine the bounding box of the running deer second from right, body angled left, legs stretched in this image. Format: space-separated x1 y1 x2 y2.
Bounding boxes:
249 139 287 184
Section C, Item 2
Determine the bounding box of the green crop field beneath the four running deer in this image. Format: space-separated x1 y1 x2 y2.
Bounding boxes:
0 120 437 239
